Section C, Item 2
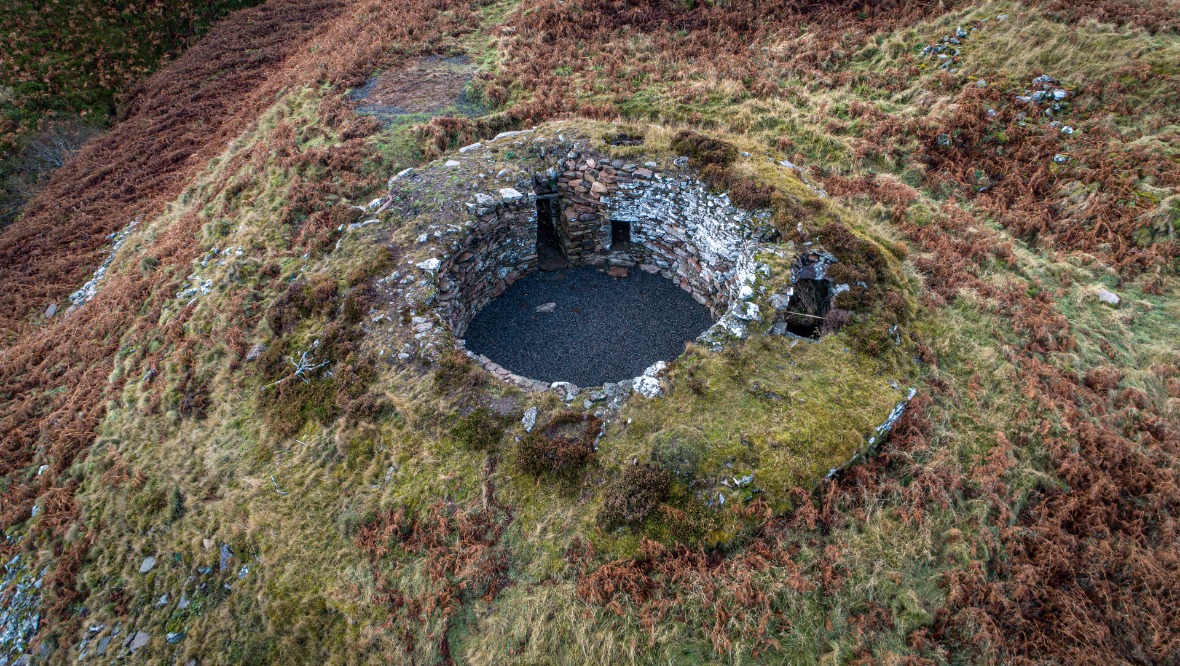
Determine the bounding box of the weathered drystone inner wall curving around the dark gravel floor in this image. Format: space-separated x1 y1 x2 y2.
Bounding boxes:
401 131 775 390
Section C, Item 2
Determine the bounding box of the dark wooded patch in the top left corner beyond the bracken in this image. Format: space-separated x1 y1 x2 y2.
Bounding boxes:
0 0 267 228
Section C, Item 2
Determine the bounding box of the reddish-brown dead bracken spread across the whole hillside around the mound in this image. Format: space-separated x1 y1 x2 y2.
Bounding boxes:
0 0 1180 662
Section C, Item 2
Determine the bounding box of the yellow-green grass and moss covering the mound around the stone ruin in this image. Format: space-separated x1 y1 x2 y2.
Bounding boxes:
25 2 1180 664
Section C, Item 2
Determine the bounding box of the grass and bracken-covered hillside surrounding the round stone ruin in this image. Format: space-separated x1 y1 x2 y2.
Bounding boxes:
0 0 1180 664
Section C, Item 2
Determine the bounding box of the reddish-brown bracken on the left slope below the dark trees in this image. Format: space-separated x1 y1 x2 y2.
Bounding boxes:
0 0 493 651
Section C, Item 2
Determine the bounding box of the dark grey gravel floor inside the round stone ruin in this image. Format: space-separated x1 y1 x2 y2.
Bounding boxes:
466 268 713 386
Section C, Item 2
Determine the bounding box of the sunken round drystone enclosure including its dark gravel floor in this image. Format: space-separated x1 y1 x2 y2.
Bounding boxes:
392 131 775 390
